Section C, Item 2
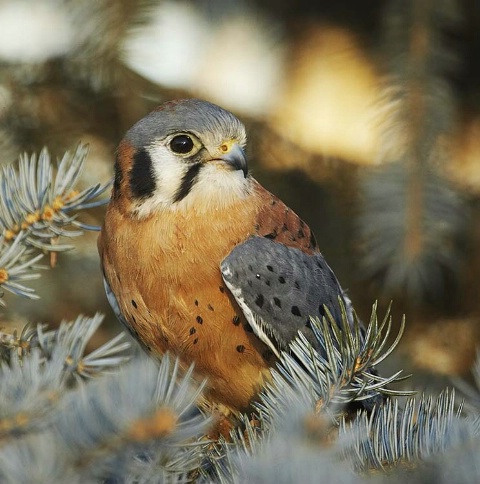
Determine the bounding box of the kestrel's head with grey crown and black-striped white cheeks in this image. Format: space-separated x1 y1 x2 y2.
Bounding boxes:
112 99 251 217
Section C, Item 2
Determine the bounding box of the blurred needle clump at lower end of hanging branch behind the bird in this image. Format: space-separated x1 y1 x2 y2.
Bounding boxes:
358 163 468 301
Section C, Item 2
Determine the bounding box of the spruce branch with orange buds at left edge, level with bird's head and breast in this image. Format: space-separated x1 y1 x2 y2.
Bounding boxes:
0 144 110 304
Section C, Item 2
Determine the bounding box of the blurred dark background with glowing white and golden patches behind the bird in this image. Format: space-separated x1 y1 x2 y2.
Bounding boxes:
0 0 480 394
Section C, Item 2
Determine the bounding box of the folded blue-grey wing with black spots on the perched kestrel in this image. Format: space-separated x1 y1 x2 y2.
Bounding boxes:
221 237 353 356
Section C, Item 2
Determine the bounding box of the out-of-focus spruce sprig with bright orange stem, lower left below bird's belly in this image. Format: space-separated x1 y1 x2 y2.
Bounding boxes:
55 355 209 482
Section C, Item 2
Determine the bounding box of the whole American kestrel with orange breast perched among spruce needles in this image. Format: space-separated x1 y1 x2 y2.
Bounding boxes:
98 99 351 411
